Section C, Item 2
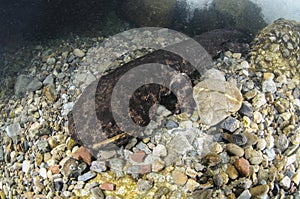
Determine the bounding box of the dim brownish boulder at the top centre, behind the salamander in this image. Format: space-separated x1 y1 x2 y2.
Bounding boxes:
122 0 176 27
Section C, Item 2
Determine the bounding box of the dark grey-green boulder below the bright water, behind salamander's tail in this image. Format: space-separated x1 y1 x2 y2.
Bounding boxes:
188 0 267 35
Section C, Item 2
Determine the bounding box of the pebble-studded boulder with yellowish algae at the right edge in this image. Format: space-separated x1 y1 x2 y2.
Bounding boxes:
250 19 300 78
